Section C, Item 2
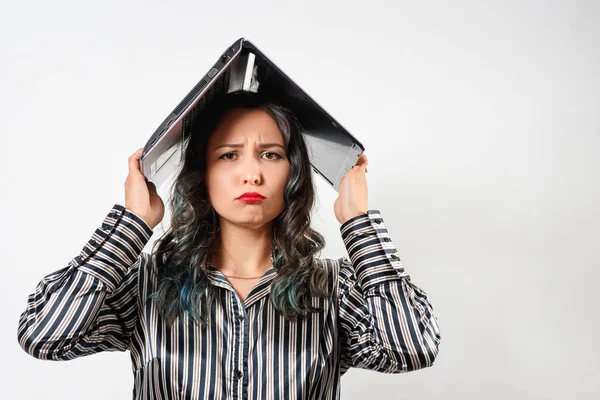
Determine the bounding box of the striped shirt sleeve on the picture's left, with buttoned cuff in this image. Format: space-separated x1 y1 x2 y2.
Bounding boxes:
17 204 152 360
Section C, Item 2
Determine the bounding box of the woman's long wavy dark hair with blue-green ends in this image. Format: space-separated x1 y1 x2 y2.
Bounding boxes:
150 92 331 326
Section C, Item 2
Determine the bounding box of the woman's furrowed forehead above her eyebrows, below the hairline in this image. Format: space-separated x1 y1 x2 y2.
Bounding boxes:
209 109 283 145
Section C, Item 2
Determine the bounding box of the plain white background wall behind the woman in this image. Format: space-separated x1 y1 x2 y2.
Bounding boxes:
0 0 600 400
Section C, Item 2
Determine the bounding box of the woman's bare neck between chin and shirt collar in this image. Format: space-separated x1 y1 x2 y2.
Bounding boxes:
209 220 273 277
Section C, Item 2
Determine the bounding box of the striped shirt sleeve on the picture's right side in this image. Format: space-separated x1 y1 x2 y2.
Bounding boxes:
338 210 441 374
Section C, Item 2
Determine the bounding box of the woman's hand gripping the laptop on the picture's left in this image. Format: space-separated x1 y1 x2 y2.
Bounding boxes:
125 148 165 229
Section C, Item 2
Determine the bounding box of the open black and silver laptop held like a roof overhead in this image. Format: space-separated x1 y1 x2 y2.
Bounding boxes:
140 38 364 191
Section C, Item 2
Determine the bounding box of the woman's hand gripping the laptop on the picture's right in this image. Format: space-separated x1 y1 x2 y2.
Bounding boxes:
333 152 369 224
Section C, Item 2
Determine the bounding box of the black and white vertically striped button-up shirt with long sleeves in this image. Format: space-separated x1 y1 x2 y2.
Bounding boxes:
17 204 441 399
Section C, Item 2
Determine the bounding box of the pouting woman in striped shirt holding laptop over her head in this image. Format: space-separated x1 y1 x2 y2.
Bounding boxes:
18 94 441 399
